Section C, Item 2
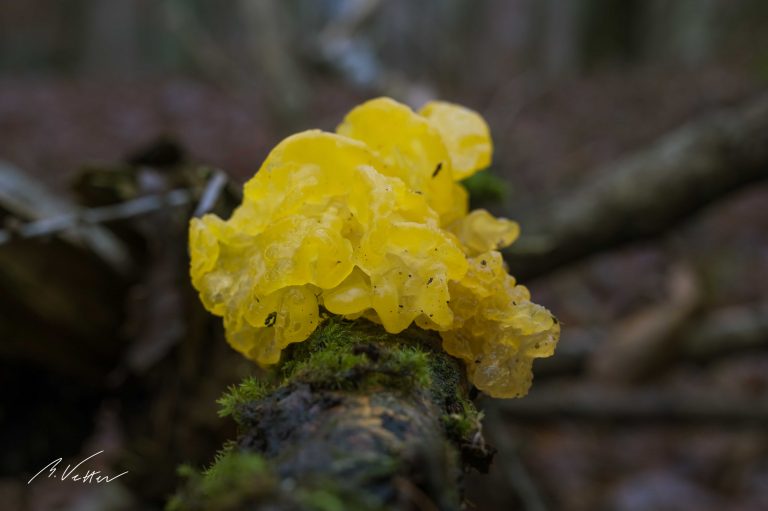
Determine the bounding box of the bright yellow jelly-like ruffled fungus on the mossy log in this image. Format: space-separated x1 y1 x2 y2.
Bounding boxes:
189 98 560 397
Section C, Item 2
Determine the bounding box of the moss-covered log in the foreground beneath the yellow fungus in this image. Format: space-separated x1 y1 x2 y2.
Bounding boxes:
169 318 492 510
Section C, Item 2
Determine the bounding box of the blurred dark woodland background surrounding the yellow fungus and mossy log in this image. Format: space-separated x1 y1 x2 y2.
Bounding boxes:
0 0 768 511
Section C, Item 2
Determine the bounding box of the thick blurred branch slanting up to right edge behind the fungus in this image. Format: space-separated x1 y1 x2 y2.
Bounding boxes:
505 94 768 279
